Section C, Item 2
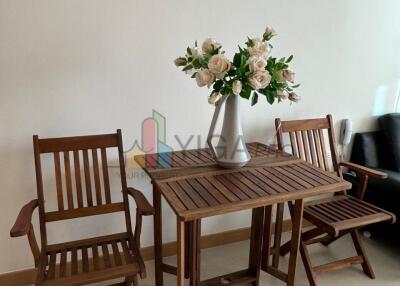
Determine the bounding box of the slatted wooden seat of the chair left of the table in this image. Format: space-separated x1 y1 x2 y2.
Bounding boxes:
39 233 143 286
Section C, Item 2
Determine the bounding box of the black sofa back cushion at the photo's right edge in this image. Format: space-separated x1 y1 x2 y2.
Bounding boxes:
378 113 400 172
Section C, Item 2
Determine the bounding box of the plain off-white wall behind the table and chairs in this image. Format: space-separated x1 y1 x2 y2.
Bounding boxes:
0 0 400 272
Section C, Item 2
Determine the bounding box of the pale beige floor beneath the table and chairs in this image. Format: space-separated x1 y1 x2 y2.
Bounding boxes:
100 233 400 286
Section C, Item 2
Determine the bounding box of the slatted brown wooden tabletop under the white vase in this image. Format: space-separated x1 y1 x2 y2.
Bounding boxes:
135 143 351 221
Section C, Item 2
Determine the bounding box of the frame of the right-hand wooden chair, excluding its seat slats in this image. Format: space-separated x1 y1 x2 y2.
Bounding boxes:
263 115 396 286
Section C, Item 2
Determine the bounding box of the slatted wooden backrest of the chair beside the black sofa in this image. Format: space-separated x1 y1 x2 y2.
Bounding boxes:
275 115 340 176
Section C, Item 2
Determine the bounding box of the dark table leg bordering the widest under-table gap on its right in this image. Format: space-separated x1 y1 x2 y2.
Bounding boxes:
249 207 264 286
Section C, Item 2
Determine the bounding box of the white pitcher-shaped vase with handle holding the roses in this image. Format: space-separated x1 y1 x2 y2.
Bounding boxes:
207 95 250 168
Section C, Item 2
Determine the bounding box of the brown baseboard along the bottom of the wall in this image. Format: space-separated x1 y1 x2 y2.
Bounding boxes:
0 220 310 286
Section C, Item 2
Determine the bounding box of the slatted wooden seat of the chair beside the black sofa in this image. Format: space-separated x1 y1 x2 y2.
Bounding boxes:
304 195 396 236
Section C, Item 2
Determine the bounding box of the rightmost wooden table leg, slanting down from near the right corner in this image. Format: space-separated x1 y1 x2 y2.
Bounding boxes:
287 200 304 286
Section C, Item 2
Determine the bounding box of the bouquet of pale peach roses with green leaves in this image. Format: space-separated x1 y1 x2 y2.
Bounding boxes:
175 27 300 105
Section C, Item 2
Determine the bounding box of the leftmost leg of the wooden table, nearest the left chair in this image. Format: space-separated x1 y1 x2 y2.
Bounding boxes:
153 185 163 286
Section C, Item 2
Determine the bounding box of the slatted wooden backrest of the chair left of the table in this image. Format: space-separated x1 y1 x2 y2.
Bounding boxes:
33 129 132 247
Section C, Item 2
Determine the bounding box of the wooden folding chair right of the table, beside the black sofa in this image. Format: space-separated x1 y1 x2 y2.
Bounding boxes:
264 115 396 286
